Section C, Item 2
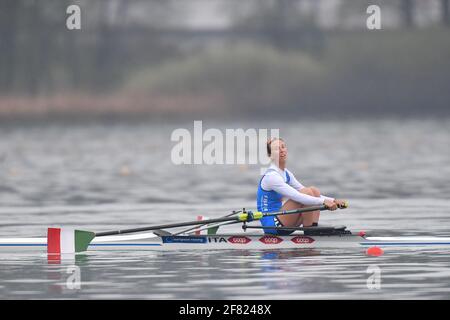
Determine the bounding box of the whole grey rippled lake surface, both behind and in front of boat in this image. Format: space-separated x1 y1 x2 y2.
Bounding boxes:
0 119 450 299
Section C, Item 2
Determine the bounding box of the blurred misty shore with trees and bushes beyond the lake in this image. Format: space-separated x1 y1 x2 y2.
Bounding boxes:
0 0 450 119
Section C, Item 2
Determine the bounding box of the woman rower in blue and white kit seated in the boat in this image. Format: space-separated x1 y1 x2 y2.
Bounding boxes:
256 138 345 235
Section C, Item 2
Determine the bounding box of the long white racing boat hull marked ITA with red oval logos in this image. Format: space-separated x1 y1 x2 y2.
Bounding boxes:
0 233 450 252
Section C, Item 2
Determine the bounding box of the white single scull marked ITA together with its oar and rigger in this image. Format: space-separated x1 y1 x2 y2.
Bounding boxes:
0 205 450 254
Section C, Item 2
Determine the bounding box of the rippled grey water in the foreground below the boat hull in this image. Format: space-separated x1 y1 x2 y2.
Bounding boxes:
0 244 450 299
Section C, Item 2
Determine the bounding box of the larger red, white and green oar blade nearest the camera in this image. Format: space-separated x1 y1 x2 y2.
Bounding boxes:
47 228 95 254
